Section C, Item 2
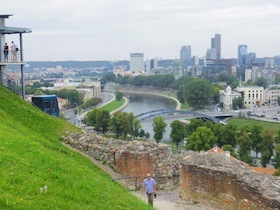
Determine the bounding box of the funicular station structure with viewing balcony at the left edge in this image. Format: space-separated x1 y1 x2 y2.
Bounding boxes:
0 15 32 99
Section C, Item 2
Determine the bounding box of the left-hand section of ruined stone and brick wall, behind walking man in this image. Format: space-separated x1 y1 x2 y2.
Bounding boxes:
64 133 179 189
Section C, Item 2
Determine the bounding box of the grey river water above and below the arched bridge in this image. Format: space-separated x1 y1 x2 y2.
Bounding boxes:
123 93 176 141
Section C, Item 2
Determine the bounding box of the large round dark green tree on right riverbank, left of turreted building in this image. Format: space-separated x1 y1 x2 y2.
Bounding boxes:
184 79 214 109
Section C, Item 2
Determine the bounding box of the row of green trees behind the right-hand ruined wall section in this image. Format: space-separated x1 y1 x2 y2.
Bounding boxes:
182 119 280 168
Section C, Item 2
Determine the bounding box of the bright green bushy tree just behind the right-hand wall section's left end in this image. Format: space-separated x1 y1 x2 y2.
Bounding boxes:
186 126 215 151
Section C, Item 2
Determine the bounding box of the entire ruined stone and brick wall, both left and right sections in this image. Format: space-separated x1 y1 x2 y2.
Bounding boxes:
64 133 280 210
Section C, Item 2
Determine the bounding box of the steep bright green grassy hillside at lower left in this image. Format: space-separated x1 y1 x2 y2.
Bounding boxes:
0 85 147 210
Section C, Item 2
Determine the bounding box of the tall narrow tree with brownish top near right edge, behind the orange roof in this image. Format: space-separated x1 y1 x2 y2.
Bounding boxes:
261 130 274 167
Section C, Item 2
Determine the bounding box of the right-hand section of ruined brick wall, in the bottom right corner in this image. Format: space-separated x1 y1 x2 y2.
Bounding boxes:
180 154 280 210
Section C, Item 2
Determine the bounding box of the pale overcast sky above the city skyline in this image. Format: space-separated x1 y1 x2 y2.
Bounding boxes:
0 0 280 61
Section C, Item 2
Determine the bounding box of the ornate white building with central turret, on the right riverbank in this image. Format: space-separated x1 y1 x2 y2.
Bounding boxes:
219 86 241 110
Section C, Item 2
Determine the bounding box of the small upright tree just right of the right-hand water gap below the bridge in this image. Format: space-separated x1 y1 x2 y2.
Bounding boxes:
170 120 186 148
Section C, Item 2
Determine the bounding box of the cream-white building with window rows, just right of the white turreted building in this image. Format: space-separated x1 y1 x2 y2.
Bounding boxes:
237 86 264 108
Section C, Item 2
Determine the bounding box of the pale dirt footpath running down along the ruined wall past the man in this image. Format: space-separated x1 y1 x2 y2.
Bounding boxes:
63 144 214 210
